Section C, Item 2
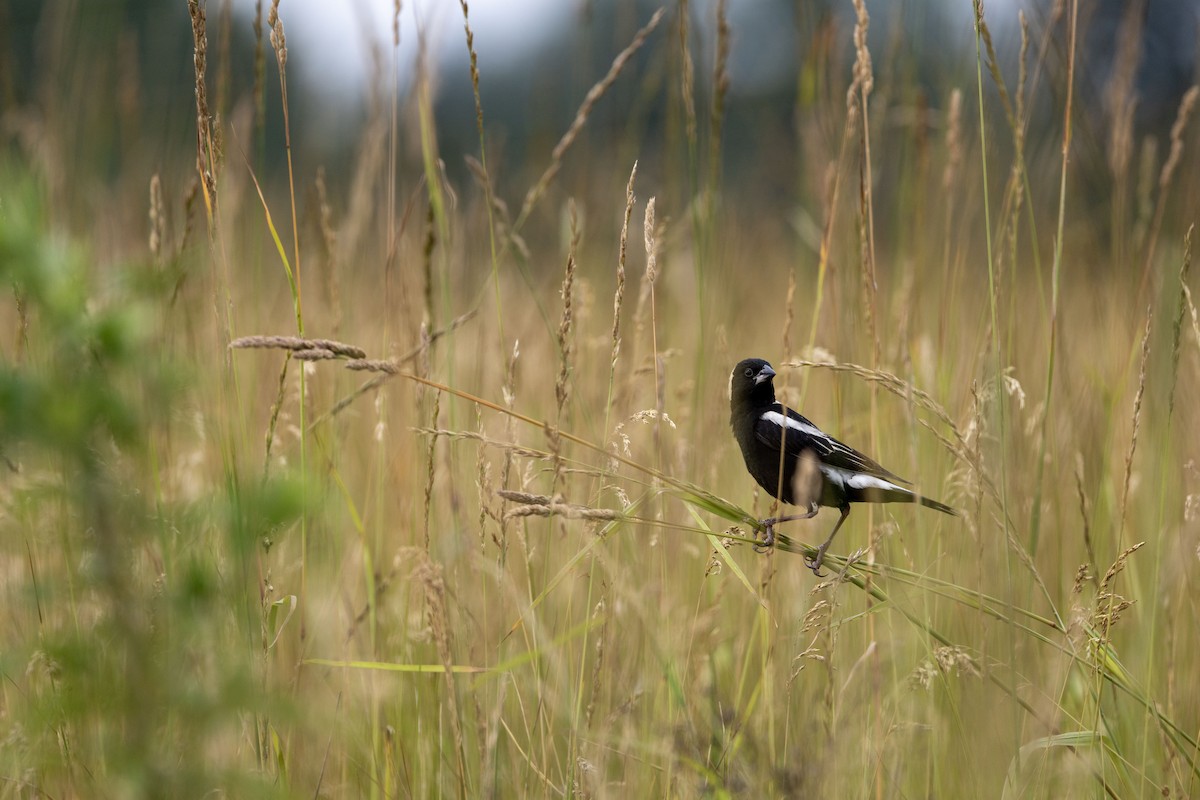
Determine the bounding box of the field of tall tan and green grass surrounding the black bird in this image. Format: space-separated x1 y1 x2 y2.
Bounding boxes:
0 2 1200 798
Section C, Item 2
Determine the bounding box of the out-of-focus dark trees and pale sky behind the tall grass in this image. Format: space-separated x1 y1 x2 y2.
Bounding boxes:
0 0 1200 227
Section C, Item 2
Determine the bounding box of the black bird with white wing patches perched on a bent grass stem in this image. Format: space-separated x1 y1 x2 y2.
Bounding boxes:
730 359 958 577
